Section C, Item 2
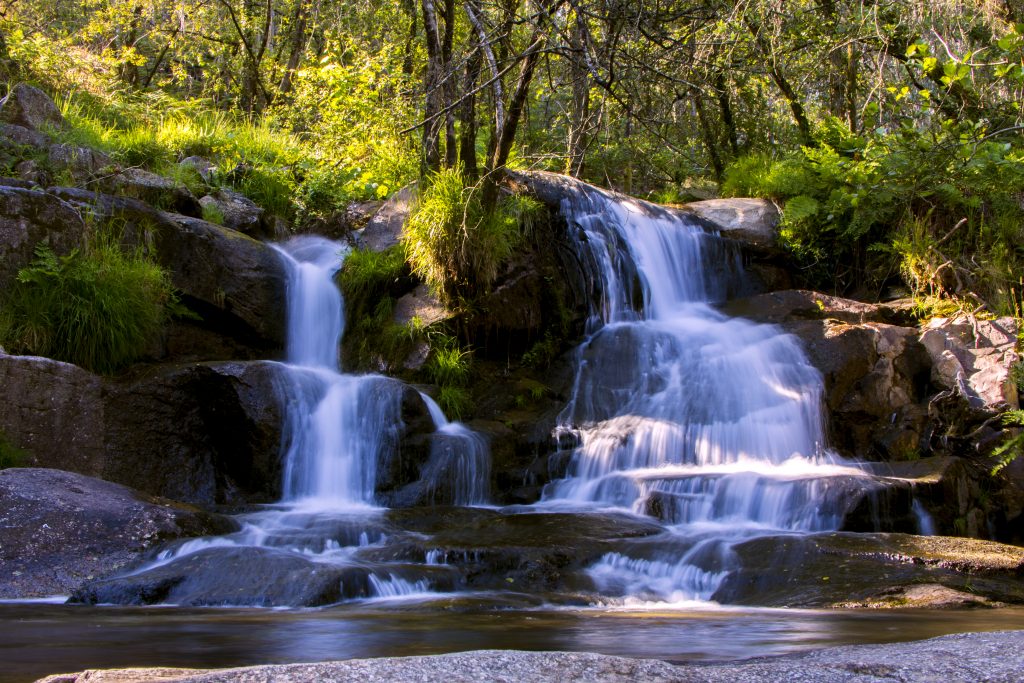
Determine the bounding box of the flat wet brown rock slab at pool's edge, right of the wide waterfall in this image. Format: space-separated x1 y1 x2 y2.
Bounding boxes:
713 532 1024 607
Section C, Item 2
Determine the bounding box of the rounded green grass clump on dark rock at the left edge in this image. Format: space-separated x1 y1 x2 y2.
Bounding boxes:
0 240 176 373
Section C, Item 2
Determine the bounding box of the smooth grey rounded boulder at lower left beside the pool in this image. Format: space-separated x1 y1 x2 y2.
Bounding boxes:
0 469 234 598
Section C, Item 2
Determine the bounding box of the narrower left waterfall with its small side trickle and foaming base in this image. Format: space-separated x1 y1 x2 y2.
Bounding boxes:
133 237 489 600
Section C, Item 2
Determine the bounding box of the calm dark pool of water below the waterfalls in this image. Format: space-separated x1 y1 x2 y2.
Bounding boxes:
0 600 1024 683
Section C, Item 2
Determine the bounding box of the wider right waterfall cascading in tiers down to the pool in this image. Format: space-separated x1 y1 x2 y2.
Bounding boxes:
542 189 880 601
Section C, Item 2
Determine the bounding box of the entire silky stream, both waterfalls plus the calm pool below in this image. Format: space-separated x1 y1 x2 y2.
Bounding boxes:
8 189 1020 680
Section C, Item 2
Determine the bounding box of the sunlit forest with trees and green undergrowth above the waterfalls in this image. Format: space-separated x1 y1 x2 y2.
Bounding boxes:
0 0 1024 315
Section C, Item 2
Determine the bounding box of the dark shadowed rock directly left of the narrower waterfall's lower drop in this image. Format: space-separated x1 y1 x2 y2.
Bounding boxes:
102 362 282 504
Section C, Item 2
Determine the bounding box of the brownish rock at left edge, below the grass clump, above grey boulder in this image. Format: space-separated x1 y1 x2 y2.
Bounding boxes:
0 352 106 476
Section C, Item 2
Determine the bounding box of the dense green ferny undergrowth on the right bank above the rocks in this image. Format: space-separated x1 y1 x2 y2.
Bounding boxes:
722 121 1024 314
